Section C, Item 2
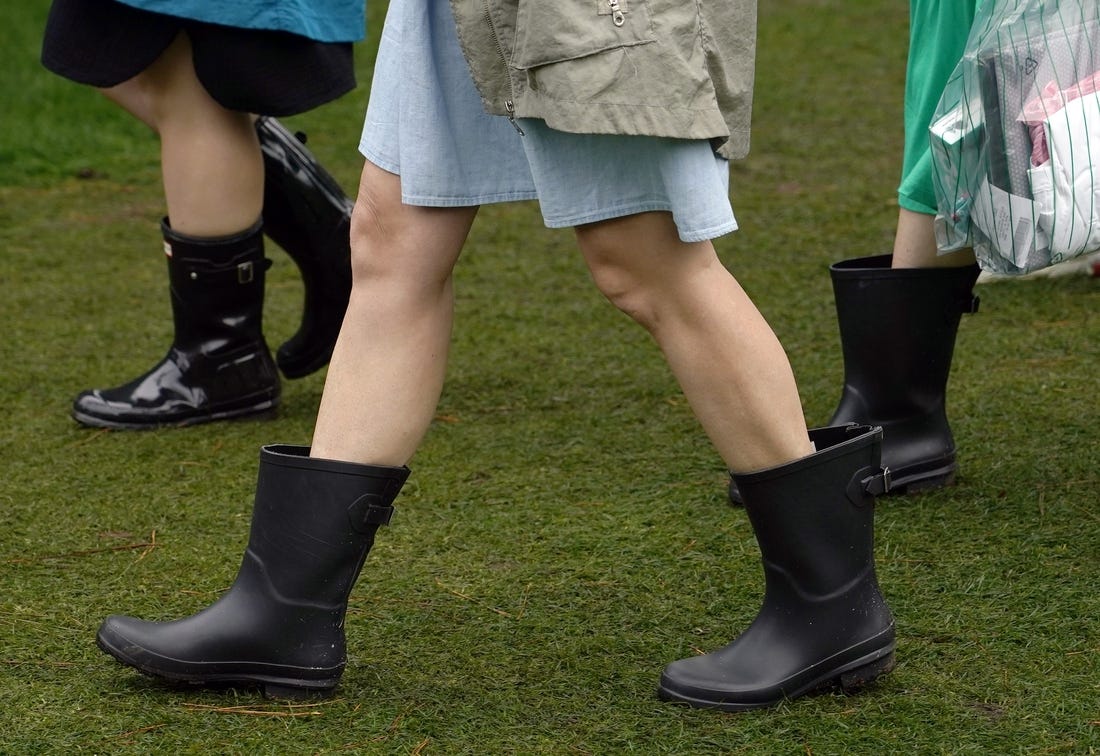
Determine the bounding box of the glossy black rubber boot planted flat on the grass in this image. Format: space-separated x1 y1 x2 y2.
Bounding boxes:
73 219 279 429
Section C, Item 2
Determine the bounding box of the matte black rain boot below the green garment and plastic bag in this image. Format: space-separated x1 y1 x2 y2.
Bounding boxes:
829 254 978 493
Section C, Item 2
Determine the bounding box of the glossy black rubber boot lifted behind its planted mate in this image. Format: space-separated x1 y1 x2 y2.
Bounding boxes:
256 117 354 379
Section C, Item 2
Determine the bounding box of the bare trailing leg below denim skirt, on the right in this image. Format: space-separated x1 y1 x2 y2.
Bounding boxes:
576 212 811 472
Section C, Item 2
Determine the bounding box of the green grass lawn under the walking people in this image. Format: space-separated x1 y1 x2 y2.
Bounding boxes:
0 0 1100 755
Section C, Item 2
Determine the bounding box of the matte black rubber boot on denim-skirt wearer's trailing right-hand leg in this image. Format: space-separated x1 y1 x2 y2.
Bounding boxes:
659 425 894 711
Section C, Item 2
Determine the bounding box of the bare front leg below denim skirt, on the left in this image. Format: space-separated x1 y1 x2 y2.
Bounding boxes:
311 162 477 465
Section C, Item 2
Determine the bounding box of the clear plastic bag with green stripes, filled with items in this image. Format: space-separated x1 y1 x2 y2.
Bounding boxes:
930 0 1100 274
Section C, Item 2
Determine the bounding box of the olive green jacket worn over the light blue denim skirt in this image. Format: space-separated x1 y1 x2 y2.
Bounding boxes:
450 0 757 158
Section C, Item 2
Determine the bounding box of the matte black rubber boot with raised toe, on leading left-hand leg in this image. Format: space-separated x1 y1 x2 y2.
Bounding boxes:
96 446 409 698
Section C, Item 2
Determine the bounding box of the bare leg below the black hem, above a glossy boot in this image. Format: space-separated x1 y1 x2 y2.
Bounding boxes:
102 34 264 238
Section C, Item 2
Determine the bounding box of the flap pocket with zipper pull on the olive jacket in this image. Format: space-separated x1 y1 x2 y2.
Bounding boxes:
512 0 657 69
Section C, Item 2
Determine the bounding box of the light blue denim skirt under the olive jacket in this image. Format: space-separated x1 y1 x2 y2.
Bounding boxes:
360 0 737 242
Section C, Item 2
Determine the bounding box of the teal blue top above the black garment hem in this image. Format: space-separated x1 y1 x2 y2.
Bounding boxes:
119 0 366 42
